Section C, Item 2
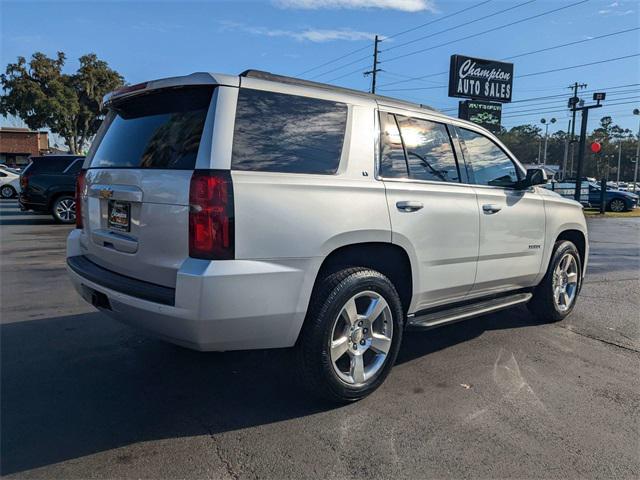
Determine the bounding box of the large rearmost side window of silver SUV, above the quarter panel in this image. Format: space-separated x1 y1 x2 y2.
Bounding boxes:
231 88 347 174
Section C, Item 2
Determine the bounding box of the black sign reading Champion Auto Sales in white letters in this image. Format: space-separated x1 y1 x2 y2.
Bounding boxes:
449 55 513 103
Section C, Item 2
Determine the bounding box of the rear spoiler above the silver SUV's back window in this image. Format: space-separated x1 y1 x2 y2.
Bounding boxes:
101 72 240 108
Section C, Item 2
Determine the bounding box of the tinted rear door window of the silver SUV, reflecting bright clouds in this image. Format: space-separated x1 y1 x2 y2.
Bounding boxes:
396 115 460 182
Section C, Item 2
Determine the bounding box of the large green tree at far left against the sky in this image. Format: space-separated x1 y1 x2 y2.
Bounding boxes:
0 52 124 153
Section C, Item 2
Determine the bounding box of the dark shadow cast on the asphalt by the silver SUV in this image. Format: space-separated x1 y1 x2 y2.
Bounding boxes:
0 309 536 475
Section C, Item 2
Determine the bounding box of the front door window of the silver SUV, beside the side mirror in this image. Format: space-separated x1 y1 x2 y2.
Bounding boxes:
458 128 519 187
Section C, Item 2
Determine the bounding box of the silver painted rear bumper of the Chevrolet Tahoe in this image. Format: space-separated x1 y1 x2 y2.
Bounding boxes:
67 230 322 351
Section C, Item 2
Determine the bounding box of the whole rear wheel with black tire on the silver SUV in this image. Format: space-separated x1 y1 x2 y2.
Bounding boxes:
296 267 404 403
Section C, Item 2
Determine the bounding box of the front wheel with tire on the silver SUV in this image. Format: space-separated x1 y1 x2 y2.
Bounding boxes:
527 240 582 322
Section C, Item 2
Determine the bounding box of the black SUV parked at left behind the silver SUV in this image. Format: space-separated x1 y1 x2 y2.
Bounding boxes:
18 155 84 223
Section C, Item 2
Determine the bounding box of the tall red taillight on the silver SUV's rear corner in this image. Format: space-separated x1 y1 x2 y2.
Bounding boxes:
189 170 234 260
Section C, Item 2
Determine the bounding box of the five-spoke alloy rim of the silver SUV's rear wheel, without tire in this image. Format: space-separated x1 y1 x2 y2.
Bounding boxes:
329 291 393 385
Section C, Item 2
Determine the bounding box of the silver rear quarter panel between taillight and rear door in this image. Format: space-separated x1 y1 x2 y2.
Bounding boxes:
231 103 391 326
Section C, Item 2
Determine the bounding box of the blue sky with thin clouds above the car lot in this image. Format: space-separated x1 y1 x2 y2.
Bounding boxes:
0 0 640 131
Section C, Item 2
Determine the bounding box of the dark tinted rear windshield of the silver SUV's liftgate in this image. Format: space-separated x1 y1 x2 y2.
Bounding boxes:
90 87 213 170
